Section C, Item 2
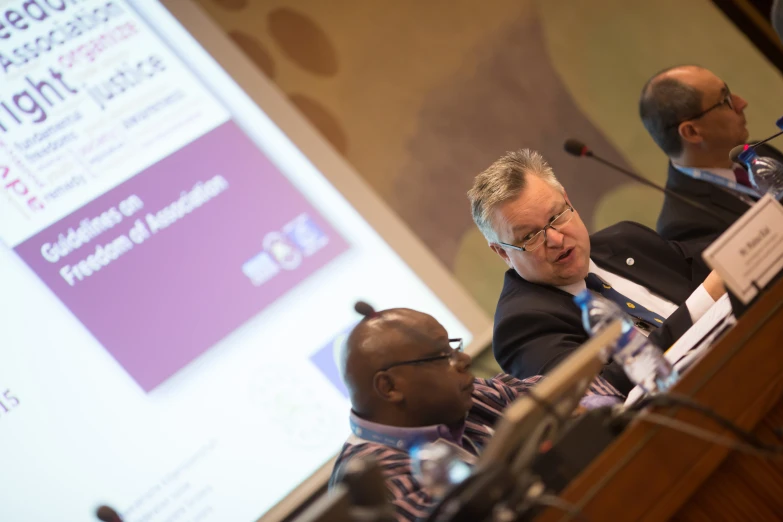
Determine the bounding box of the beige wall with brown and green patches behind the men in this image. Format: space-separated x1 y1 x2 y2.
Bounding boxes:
199 0 783 320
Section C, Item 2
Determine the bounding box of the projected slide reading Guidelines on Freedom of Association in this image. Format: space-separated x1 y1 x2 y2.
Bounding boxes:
0 0 480 522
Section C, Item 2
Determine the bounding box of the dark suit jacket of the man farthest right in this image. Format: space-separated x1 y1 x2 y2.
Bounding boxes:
656 140 783 241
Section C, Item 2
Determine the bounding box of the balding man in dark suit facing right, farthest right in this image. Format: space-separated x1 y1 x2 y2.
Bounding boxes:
639 65 783 241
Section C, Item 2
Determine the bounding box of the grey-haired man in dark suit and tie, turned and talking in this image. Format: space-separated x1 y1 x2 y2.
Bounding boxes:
468 149 725 393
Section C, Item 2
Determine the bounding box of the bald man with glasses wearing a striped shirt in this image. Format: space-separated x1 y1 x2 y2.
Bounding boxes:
329 302 623 520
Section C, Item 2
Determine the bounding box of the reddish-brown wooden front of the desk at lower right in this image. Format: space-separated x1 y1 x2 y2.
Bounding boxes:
539 274 783 522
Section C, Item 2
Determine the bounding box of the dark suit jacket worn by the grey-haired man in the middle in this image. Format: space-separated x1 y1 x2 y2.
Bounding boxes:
492 221 713 394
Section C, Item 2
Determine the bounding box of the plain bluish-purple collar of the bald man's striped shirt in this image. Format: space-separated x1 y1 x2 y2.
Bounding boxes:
351 411 465 450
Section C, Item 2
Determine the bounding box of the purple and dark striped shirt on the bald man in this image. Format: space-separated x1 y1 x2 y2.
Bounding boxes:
329 373 625 521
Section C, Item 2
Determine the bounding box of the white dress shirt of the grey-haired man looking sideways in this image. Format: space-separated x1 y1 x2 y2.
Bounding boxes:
558 259 715 323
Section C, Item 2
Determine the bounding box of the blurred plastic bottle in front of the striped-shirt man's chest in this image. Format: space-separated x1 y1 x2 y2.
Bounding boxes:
410 442 472 497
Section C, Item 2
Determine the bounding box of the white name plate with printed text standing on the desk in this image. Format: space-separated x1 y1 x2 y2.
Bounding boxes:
703 194 783 304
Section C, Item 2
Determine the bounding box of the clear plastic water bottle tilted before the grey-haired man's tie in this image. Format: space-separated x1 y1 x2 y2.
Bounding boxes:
574 290 679 393
